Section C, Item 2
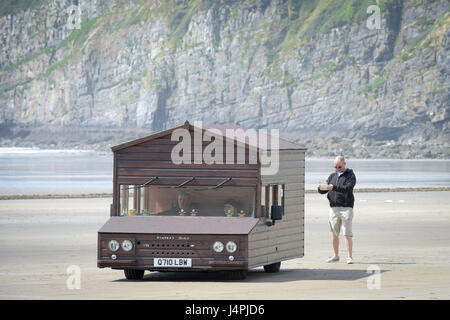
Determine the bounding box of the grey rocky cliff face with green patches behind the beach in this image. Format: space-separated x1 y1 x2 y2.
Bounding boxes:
0 0 450 158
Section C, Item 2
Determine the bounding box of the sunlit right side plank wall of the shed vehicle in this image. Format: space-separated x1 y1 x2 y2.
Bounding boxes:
248 150 305 268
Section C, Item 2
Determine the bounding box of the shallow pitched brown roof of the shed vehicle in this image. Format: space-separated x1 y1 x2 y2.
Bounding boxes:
111 121 306 152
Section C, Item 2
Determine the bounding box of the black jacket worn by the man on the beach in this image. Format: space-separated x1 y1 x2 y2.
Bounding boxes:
318 168 356 208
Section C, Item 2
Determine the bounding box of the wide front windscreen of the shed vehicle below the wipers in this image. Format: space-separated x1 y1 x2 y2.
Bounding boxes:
120 185 256 217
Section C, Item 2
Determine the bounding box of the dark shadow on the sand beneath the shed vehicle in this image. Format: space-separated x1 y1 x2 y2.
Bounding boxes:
114 269 390 283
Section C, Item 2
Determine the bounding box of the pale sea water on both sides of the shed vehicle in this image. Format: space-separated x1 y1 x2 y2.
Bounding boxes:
0 148 450 195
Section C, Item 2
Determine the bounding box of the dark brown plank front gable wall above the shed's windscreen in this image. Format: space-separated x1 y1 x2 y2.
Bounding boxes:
114 132 259 215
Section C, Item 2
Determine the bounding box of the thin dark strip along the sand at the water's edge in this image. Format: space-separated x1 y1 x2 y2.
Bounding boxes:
0 187 450 201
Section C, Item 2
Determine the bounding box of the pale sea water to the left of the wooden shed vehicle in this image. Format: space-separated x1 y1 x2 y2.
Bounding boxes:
0 148 113 195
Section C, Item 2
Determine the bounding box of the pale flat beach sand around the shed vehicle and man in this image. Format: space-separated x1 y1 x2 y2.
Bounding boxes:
0 191 450 300
